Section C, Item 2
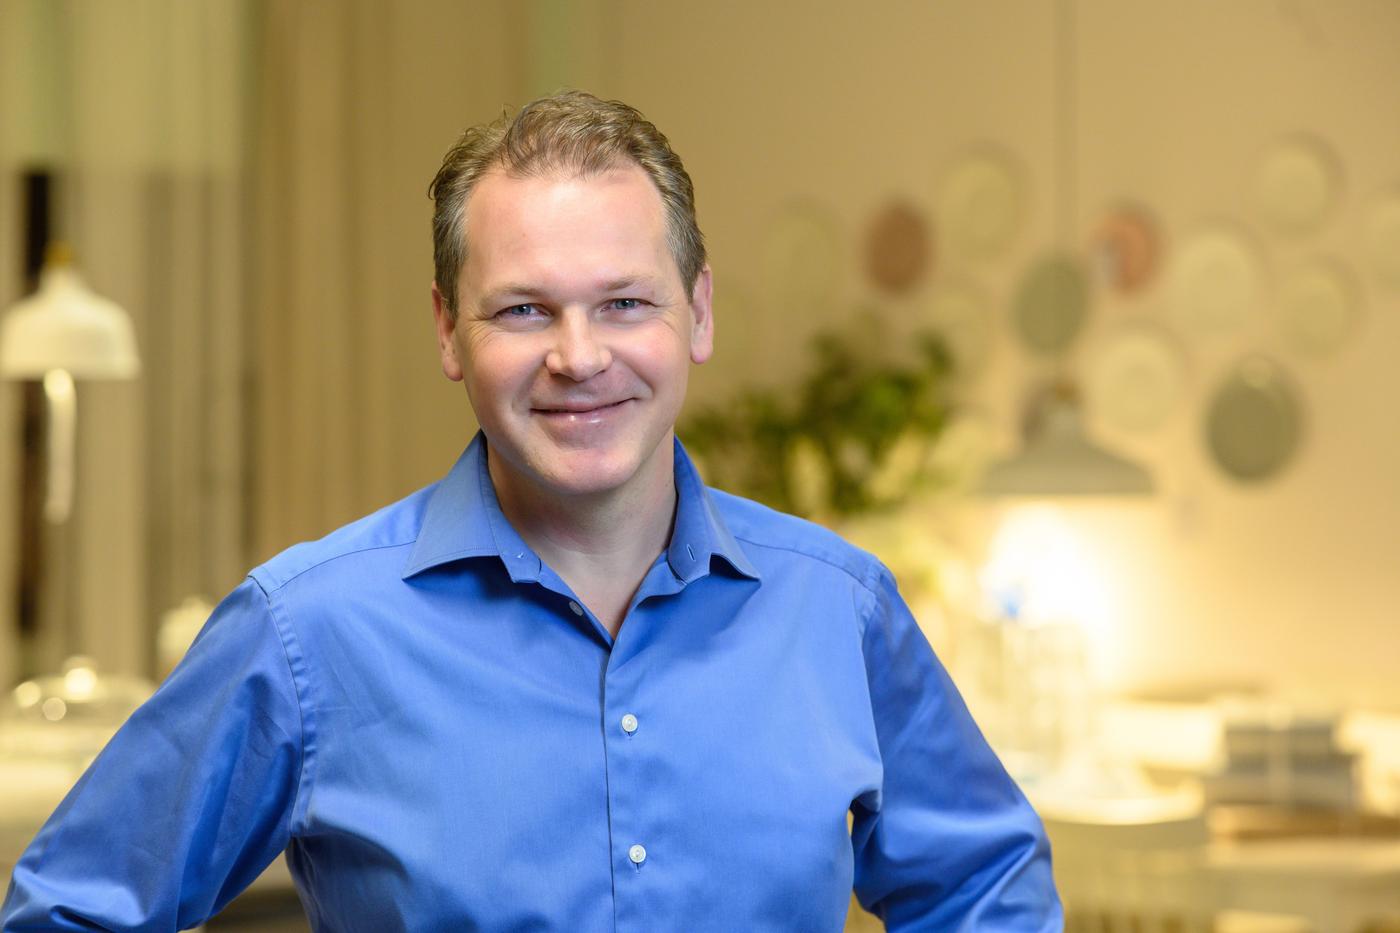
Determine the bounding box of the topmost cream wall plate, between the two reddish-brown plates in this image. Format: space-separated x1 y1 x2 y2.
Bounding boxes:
938 146 1025 259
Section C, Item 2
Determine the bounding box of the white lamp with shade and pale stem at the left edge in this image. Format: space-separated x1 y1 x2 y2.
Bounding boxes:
0 244 141 524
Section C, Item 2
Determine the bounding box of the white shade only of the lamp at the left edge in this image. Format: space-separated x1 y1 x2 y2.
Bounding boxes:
0 265 141 380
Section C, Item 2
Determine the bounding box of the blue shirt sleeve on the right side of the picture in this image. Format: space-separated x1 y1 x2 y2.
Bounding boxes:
851 567 1063 933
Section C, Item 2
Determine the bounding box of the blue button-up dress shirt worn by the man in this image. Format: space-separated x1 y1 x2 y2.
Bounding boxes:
3 436 1060 933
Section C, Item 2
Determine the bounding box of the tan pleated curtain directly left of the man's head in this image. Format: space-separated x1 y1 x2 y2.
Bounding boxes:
252 0 526 559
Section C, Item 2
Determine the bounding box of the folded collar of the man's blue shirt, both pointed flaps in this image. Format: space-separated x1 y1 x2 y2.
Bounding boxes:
403 431 759 583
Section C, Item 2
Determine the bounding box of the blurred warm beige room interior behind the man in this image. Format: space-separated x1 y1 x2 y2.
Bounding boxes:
0 0 1400 930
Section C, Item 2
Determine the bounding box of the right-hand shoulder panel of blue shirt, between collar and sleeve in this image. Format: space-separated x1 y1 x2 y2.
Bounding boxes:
707 488 883 590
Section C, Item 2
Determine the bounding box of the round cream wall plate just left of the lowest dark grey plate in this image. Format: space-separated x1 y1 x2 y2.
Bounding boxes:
1084 325 1186 431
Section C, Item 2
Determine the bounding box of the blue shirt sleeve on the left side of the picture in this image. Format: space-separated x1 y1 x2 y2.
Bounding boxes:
0 579 302 933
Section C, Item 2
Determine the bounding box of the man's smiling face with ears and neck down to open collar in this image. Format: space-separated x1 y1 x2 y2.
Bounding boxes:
433 159 713 636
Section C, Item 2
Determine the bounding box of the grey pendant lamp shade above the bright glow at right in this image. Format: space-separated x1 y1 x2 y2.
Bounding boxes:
979 382 1152 497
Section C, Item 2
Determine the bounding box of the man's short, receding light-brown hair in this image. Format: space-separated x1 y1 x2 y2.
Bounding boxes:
428 91 706 321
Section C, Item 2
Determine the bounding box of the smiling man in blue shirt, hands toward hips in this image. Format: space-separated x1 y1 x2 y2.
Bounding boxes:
4 92 1058 933
